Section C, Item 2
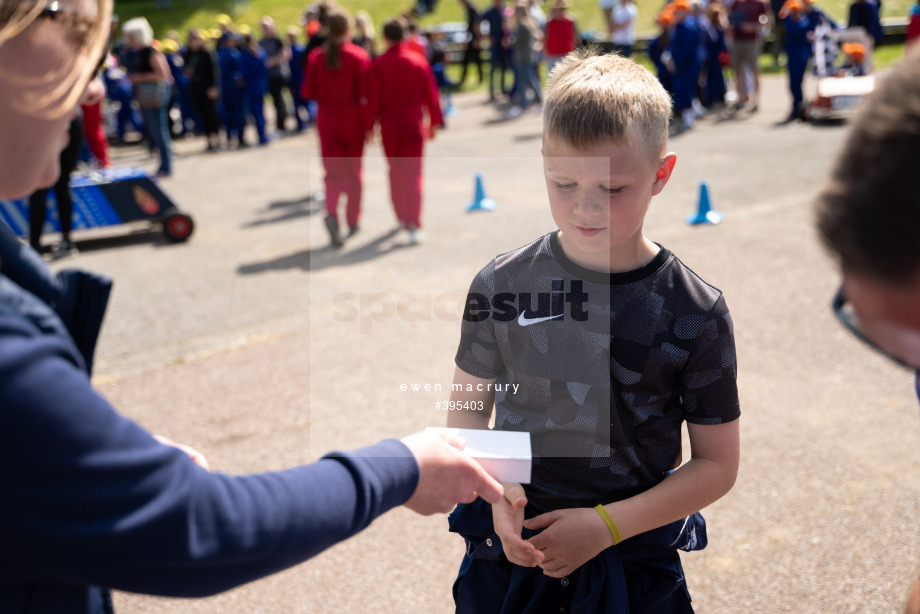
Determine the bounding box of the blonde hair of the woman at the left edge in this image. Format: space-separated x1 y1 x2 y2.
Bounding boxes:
0 0 112 117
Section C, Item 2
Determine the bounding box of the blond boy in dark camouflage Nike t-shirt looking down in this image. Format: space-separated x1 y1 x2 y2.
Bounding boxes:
448 51 740 614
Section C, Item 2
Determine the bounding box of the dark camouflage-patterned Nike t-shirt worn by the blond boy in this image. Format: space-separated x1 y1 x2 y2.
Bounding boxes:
456 232 740 514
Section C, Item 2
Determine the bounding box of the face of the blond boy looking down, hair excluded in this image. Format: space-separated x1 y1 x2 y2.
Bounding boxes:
543 137 676 271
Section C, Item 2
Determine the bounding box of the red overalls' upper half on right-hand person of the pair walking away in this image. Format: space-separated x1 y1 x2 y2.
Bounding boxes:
370 43 444 134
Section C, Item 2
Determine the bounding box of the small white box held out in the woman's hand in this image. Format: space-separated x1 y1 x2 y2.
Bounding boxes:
425 426 533 484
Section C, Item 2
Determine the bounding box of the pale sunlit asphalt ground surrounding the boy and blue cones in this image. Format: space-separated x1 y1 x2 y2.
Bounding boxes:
46 71 920 614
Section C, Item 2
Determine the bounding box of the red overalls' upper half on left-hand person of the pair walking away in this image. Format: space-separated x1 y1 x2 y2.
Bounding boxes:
300 42 374 132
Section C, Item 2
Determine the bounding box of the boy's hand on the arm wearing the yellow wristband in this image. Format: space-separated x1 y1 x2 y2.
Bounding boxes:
524 507 613 578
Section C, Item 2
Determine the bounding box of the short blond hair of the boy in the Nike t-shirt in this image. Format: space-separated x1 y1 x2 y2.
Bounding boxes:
543 46 671 165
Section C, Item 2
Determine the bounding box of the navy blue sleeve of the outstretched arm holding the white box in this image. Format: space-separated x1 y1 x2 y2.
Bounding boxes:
0 317 419 597
